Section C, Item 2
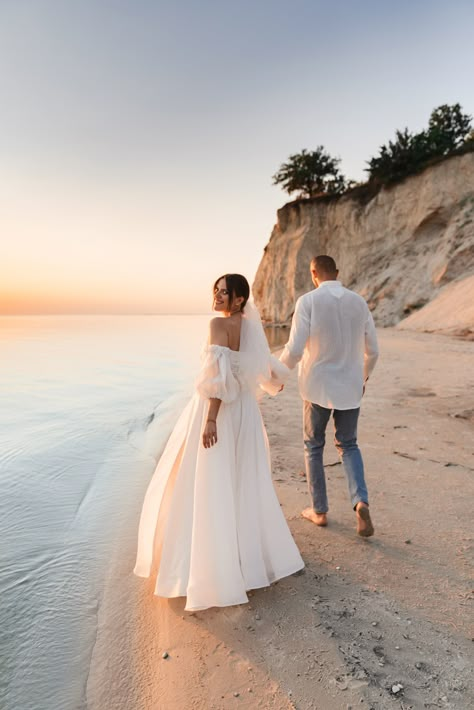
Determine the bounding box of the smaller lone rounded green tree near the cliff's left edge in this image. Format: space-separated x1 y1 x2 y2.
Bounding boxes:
273 145 347 198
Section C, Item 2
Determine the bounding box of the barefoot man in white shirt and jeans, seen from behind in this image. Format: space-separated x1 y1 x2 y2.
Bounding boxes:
280 256 378 537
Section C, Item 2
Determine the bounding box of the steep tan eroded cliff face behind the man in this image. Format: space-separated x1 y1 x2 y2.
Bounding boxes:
253 153 474 325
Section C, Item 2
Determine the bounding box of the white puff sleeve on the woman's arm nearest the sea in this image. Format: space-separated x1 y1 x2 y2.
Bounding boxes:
196 345 240 403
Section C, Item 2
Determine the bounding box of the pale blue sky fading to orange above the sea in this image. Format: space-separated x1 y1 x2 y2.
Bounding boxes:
0 0 474 314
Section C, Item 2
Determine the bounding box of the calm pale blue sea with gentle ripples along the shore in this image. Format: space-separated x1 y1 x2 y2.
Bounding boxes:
0 316 208 710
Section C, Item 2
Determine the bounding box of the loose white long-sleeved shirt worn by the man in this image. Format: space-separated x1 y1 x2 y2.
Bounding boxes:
280 281 378 409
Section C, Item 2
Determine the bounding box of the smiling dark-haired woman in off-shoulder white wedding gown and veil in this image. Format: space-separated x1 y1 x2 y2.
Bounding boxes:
134 274 304 611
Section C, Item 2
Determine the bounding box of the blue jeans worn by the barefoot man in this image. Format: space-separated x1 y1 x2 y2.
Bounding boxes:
303 402 369 513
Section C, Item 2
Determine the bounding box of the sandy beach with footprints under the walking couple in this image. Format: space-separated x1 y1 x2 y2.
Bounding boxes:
86 329 474 710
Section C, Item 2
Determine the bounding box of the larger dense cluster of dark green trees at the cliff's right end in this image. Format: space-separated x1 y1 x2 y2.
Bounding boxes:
367 104 472 183
